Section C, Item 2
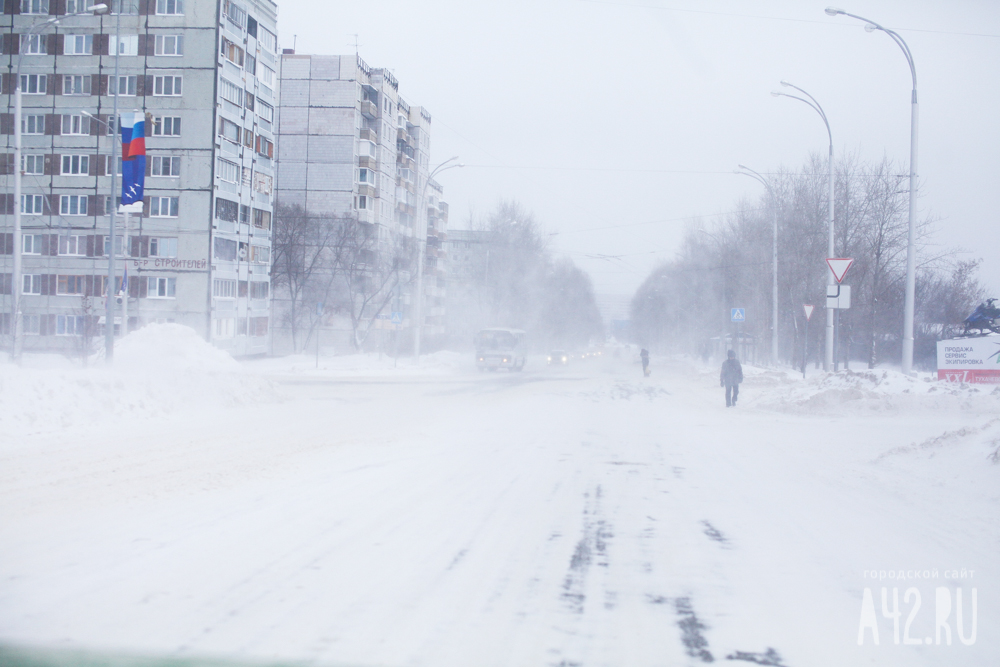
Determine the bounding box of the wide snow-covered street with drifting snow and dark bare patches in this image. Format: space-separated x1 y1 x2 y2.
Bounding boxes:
0 348 1000 667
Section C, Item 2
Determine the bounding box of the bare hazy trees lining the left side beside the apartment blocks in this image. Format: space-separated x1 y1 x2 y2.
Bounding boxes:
271 201 603 351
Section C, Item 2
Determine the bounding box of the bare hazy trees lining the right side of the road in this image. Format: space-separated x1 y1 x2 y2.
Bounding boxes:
631 156 983 368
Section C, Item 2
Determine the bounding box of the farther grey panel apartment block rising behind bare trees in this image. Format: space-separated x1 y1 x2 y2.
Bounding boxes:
277 50 447 350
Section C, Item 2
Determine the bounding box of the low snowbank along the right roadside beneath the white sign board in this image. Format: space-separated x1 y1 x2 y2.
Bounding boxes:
744 369 1000 413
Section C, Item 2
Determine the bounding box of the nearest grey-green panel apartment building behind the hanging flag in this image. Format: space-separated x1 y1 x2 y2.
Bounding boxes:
0 0 278 354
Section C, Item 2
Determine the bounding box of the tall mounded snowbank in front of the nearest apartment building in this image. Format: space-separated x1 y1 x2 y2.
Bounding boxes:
0 324 278 435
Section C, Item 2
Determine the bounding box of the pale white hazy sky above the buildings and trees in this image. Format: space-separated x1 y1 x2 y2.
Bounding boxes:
279 0 1000 296
